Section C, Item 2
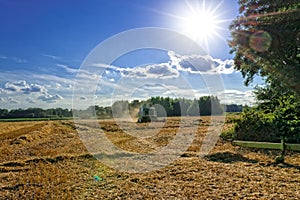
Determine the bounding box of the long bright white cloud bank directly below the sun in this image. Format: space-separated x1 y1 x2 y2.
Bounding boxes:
89 51 236 81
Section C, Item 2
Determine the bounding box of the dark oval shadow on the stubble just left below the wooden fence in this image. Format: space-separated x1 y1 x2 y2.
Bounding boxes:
205 152 258 163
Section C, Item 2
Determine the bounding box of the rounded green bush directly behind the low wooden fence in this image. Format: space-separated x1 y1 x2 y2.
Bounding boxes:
232 95 300 143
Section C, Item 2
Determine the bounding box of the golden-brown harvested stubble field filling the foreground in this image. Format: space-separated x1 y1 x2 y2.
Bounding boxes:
0 117 300 199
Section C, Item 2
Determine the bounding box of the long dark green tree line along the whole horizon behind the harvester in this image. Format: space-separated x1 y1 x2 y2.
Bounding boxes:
0 96 243 119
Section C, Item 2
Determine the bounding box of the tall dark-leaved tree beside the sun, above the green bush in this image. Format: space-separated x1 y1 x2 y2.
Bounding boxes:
229 0 300 95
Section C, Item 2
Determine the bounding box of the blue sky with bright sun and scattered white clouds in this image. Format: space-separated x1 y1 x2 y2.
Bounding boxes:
0 0 261 109
